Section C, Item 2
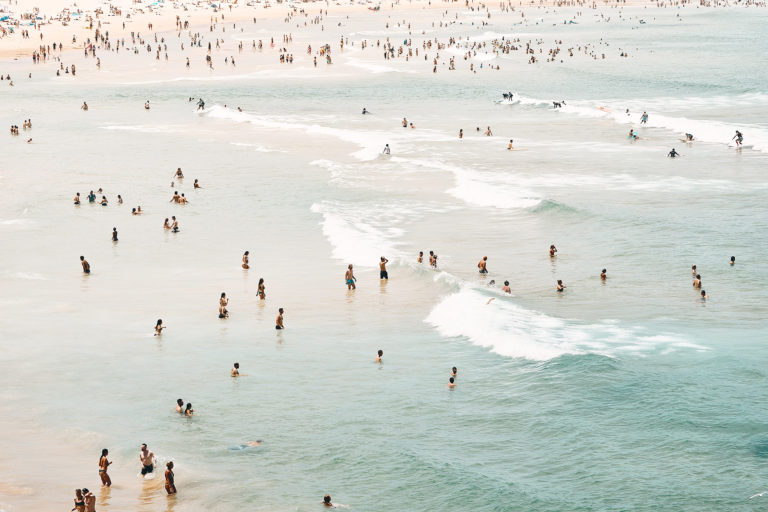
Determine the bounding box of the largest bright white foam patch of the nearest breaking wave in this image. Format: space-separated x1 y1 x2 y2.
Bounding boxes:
425 285 706 361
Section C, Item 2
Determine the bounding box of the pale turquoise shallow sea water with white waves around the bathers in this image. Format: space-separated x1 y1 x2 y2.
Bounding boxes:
0 5 768 511
